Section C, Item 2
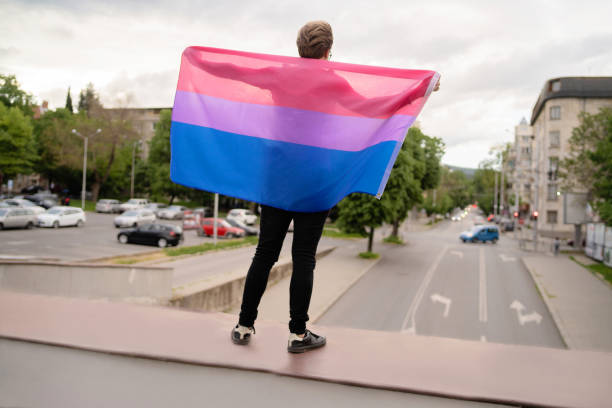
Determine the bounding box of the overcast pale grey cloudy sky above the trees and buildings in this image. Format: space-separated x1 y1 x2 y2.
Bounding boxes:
0 0 612 167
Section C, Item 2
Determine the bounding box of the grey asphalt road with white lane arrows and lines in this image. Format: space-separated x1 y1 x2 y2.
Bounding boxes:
317 212 565 348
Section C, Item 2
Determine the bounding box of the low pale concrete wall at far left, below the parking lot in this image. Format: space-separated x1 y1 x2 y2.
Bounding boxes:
0 261 173 304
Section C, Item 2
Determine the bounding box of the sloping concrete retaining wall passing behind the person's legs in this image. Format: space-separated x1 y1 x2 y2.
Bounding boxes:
170 247 336 312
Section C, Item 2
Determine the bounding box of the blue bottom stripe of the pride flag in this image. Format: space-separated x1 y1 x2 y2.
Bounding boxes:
170 122 398 212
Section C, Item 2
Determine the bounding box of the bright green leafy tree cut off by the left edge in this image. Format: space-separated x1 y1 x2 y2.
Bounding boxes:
0 102 36 184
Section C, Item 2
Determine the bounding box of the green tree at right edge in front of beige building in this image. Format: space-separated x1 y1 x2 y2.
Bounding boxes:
559 108 612 225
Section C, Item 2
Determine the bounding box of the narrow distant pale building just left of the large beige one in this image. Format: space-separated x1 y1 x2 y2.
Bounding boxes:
508 118 534 217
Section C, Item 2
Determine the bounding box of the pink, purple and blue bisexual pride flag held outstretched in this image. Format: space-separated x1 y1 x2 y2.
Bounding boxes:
170 47 438 212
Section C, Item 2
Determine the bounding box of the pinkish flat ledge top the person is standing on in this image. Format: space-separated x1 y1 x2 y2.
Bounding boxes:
0 292 612 407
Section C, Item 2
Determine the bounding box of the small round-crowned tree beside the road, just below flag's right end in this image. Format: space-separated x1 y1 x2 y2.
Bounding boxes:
337 193 385 252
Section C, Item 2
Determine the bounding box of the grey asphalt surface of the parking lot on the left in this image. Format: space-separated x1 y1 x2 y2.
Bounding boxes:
0 212 237 261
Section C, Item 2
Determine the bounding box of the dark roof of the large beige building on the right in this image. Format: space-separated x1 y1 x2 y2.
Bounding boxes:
531 77 612 126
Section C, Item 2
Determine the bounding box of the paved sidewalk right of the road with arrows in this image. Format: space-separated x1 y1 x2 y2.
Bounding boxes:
522 255 612 351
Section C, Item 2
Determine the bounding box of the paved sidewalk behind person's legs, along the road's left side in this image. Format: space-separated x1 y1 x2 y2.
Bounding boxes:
229 241 381 323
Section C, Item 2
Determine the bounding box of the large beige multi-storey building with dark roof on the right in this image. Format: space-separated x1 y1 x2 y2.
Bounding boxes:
531 77 612 237
